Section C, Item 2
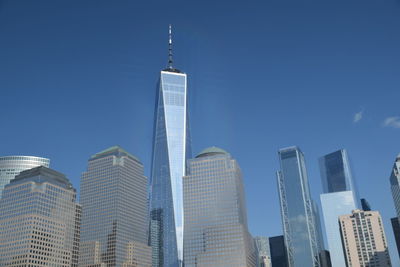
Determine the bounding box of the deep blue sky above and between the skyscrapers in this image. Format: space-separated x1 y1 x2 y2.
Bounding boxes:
0 0 400 264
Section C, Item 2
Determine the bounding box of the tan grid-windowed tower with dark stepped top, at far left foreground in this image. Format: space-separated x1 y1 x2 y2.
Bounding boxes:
0 166 80 267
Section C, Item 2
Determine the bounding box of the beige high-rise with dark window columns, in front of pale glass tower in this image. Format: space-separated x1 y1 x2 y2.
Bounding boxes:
339 210 392 267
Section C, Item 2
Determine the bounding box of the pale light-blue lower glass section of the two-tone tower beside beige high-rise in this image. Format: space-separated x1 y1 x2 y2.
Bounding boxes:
321 191 356 266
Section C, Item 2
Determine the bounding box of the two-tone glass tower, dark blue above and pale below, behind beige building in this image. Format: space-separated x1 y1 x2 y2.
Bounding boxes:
319 149 357 267
